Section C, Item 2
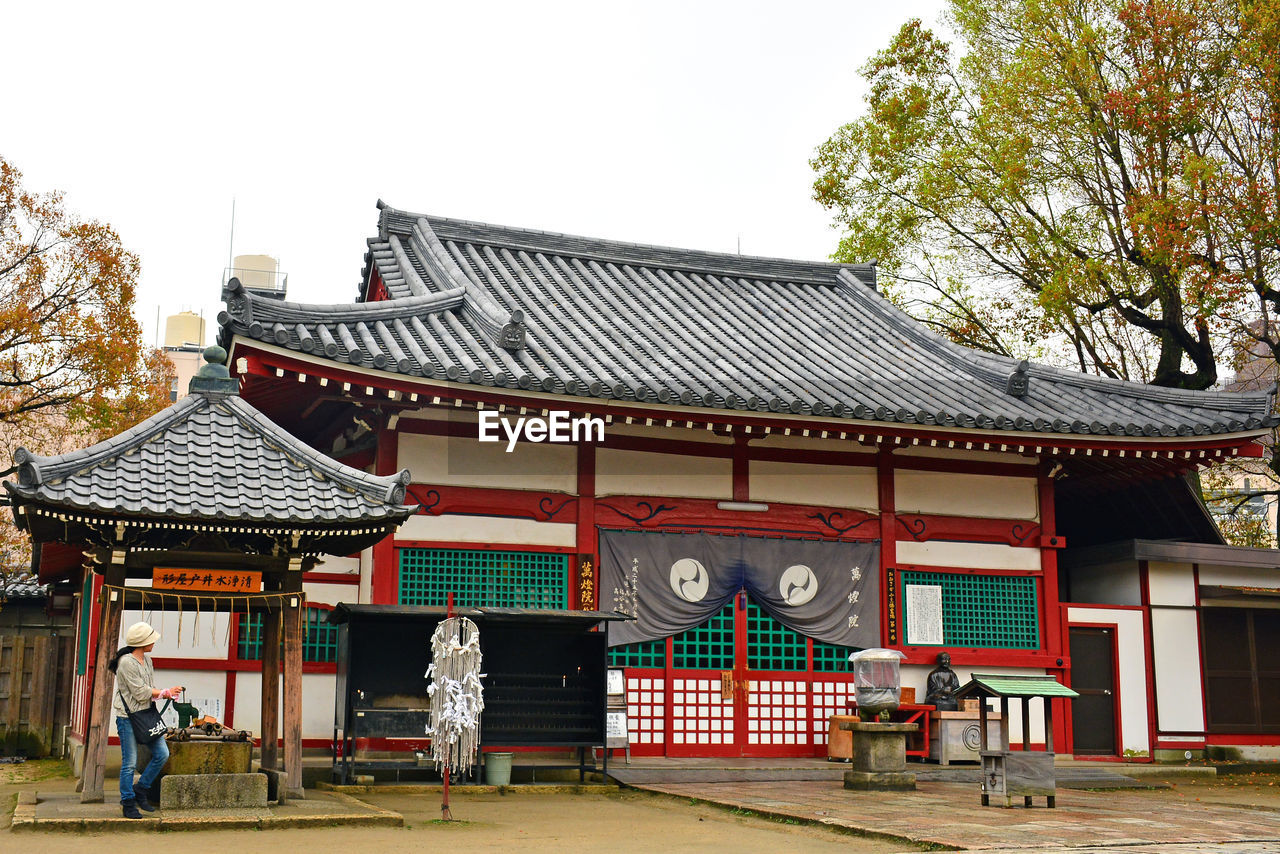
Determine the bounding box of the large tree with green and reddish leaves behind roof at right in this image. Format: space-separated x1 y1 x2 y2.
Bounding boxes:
812 0 1280 545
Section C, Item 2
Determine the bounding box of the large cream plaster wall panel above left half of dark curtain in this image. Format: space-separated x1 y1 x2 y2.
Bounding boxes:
595 448 733 501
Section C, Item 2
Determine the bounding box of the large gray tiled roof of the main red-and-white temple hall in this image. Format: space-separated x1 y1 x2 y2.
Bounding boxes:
219 205 1276 437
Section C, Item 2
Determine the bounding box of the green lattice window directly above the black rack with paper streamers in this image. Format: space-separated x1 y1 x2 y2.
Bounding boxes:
399 548 568 608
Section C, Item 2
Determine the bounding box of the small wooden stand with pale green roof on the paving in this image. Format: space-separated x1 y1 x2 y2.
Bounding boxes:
956 673 1079 809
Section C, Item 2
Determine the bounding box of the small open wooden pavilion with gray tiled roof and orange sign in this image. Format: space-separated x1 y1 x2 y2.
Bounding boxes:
5 347 413 800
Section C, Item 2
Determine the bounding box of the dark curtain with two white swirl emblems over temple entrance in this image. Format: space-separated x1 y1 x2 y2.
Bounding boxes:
600 530 881 648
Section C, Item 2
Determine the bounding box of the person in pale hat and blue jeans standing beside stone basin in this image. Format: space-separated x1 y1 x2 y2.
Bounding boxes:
108 622 182 818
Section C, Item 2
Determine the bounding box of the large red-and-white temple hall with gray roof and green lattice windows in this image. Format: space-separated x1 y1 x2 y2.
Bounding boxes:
12 204 1280 758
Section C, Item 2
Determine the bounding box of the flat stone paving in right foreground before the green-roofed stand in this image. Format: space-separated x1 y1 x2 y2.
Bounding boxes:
637 780 1280 854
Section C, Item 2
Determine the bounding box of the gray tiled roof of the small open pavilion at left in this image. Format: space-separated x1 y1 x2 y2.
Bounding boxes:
4 393 412 525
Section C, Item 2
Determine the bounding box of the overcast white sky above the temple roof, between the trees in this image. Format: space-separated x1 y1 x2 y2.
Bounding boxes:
0 0 942 342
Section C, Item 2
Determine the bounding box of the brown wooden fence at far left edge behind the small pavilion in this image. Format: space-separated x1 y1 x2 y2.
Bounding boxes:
0 632 74 757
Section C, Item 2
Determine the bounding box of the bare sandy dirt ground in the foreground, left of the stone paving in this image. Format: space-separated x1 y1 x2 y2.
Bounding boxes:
0 762 913 854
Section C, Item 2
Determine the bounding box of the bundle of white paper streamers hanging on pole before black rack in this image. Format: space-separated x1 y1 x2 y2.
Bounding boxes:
426 617 484 773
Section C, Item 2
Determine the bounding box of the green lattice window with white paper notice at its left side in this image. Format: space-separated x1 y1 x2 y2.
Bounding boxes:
901 571 1039 649
